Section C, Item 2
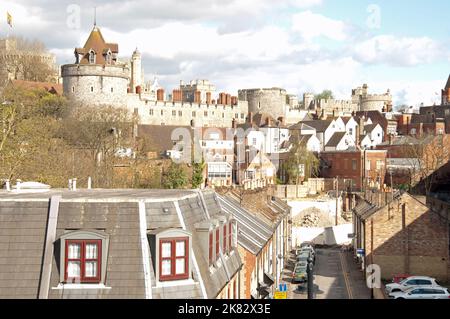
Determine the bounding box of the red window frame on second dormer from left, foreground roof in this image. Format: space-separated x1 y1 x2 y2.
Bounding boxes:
159 237 189 281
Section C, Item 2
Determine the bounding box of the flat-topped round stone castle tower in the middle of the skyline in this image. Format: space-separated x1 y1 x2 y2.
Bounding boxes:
238 88 287 119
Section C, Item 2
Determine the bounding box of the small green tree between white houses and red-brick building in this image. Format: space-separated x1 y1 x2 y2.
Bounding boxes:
284 141 319 185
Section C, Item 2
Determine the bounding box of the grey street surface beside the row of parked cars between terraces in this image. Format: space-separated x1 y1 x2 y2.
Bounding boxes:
282 248 371 299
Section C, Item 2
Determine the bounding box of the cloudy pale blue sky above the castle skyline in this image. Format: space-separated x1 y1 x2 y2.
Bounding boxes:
0 0 450 106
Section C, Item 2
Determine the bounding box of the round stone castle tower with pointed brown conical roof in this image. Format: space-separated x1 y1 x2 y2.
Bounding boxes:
61 26 130 108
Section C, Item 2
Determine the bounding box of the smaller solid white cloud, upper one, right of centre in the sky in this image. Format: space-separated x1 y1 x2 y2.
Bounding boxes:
292 11 348 41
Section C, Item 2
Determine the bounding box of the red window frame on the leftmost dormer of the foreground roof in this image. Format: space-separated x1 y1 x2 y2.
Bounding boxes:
64 239 102 283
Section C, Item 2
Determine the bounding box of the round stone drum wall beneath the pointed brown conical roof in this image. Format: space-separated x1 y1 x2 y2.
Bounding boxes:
61 64 130 107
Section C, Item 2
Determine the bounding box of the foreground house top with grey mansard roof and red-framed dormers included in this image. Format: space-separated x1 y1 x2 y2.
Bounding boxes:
0 189 246 299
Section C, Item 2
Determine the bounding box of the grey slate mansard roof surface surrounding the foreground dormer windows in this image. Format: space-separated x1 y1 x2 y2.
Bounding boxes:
0 189 242 299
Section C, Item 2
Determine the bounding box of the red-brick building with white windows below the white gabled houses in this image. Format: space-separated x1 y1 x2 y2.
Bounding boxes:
319 149 387 189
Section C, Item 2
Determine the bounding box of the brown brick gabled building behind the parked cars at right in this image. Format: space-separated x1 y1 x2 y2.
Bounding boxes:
353 193 450 282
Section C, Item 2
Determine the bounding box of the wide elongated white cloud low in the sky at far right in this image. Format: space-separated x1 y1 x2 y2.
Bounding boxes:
354 35 445 66
